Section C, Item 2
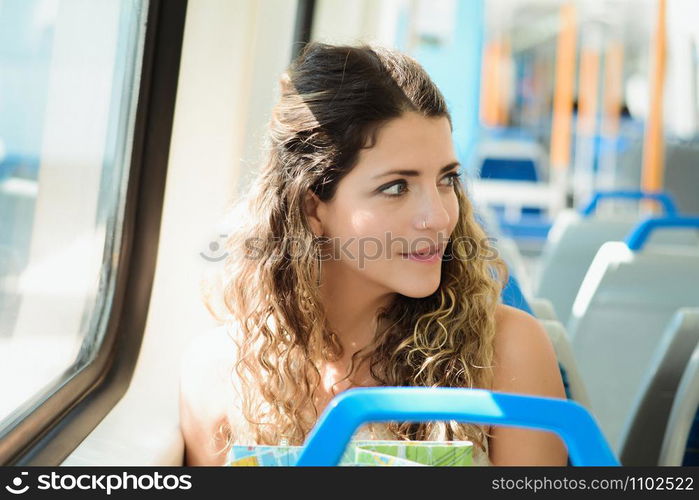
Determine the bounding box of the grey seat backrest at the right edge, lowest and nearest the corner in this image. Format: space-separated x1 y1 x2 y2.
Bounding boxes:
659 345 699 465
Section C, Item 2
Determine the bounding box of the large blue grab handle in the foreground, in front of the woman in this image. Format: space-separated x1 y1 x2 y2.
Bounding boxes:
296 387 619 466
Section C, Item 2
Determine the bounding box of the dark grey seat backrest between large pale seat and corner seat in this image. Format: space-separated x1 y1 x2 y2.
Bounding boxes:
619 309 699 465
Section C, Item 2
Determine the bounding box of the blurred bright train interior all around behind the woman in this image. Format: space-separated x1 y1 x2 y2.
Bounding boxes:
0 0 699 466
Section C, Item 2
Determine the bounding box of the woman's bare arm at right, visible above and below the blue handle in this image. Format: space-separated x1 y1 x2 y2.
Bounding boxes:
489 306 567 465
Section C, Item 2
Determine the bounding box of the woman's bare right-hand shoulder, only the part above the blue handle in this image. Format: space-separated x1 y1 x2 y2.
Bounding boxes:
493 305 565 398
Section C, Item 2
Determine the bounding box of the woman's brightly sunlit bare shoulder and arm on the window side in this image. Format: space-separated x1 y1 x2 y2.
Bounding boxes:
179 327 241 465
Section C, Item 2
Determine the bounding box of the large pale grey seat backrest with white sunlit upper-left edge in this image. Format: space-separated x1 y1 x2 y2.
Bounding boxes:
568 242 699 451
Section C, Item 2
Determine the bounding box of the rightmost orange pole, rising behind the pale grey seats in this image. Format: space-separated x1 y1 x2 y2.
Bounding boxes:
641 0 666 191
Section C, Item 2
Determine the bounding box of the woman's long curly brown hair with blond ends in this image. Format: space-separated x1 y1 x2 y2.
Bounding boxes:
206 43 506 458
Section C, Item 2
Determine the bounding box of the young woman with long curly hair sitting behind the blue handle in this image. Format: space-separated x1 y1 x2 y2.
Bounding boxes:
181 43 566 465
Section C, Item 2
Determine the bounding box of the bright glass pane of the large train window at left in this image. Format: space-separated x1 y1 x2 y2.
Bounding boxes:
0 0 148 437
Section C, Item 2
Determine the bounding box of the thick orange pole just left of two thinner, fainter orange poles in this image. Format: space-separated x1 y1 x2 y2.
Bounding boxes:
551 4 576 171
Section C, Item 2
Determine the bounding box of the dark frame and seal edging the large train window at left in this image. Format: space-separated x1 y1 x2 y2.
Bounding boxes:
0 0 187 466
